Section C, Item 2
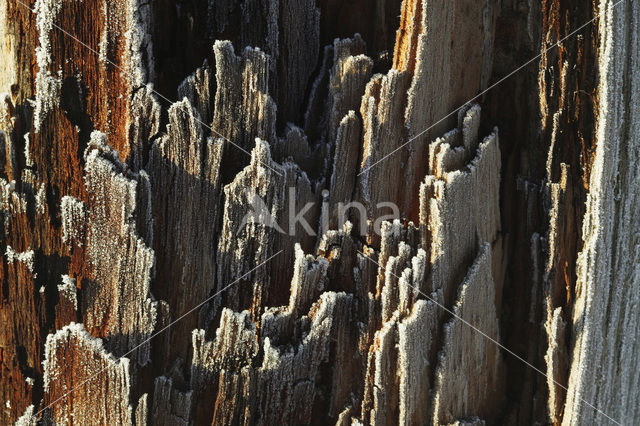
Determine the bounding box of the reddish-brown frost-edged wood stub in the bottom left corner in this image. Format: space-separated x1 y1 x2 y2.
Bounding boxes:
43 323 132 425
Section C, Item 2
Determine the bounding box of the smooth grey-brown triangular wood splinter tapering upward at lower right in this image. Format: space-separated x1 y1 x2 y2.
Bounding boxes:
433 243 502 424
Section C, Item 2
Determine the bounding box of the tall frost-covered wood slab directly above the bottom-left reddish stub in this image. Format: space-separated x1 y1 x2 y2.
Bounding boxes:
82 132 157 365
